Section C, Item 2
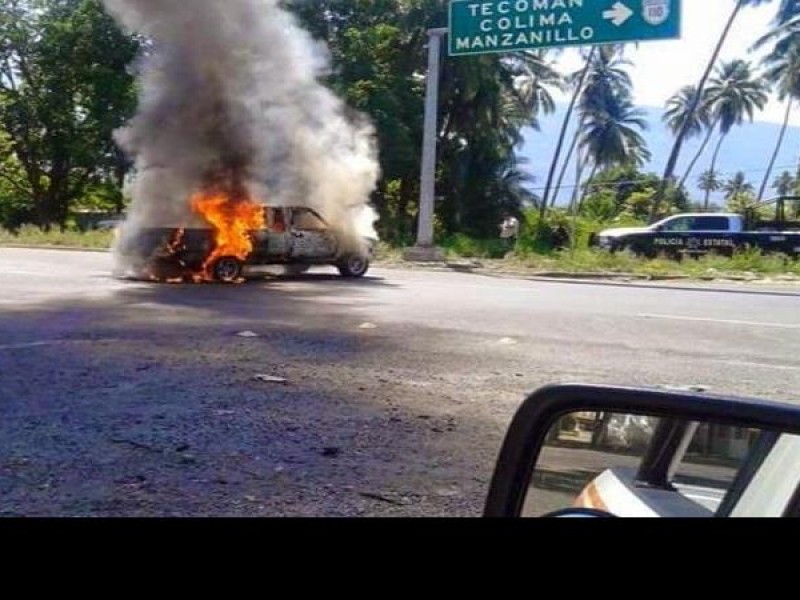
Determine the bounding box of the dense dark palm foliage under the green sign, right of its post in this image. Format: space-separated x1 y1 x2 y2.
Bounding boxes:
438 44 560 235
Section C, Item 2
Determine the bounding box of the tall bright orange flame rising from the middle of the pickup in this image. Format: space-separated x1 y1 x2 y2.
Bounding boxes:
191 192 266 281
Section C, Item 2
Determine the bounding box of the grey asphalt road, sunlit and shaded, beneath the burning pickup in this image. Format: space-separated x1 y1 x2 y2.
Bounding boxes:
0 249 800 516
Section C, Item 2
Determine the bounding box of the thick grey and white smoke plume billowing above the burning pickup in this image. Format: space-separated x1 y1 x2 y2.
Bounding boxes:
103 0 378 244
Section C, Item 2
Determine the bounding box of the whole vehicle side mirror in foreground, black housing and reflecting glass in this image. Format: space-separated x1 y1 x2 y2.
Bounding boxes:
484 385 800 518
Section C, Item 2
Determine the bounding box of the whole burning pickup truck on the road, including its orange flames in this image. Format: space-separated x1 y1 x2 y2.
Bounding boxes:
116 203 377 283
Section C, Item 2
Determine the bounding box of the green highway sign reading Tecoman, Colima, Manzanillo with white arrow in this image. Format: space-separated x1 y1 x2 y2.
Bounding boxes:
450 0 681 56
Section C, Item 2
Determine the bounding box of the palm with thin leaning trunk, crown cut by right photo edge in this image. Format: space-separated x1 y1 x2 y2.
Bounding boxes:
758 33 800 201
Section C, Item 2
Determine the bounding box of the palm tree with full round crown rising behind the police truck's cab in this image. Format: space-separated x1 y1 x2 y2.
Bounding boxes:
706 59 769 208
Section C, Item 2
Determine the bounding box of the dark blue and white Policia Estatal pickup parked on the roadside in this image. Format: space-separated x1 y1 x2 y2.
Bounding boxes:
593 197 800 258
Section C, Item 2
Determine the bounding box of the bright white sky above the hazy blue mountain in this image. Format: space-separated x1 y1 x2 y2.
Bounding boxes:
559 0 800 126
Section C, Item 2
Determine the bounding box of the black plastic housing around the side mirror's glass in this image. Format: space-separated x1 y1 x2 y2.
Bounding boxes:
484 385 800 518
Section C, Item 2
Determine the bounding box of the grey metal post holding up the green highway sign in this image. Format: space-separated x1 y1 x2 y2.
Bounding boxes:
405 28 449 262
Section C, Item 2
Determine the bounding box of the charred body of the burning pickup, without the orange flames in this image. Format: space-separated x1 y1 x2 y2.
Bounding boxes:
116 206 377 283
